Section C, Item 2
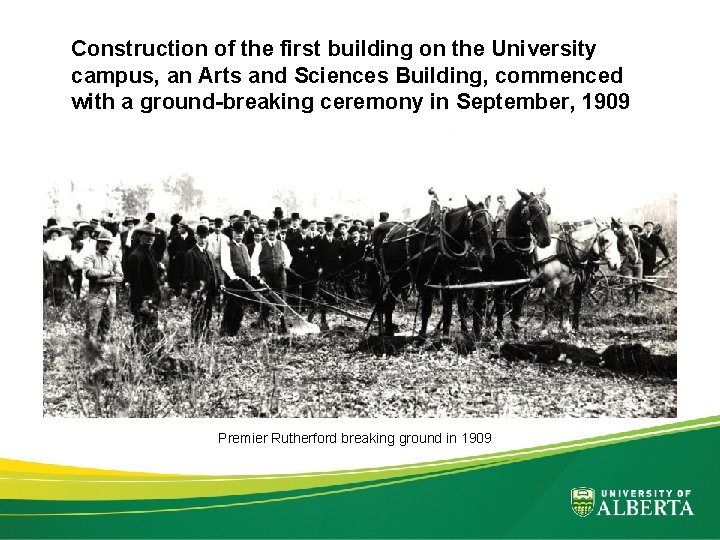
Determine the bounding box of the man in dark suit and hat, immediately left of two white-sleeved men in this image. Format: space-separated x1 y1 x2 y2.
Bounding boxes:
182 224 220 341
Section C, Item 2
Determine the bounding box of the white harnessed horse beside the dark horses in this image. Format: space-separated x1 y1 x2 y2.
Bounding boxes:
530 220 620 331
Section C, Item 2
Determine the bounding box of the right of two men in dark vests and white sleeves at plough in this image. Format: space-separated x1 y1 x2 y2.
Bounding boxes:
250 219 292 332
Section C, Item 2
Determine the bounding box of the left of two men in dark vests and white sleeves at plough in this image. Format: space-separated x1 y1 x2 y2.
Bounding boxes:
220 221 255 336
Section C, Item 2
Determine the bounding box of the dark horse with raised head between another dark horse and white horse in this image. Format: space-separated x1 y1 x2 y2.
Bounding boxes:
473 189 550 337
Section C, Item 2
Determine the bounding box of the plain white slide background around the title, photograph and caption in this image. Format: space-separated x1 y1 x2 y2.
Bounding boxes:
0 2 720 474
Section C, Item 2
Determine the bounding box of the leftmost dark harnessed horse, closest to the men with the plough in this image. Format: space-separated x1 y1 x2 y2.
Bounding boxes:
368 199 495 336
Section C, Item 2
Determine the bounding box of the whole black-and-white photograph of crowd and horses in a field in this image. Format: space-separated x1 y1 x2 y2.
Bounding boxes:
43 177 677 418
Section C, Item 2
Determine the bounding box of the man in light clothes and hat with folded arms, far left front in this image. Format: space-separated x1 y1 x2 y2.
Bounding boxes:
83 231 123 341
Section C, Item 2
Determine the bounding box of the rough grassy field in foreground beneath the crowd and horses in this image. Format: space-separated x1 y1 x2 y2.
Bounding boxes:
43 269 677 417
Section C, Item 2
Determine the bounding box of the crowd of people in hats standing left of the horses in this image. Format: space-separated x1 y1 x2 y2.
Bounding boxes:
43 207 389 352
